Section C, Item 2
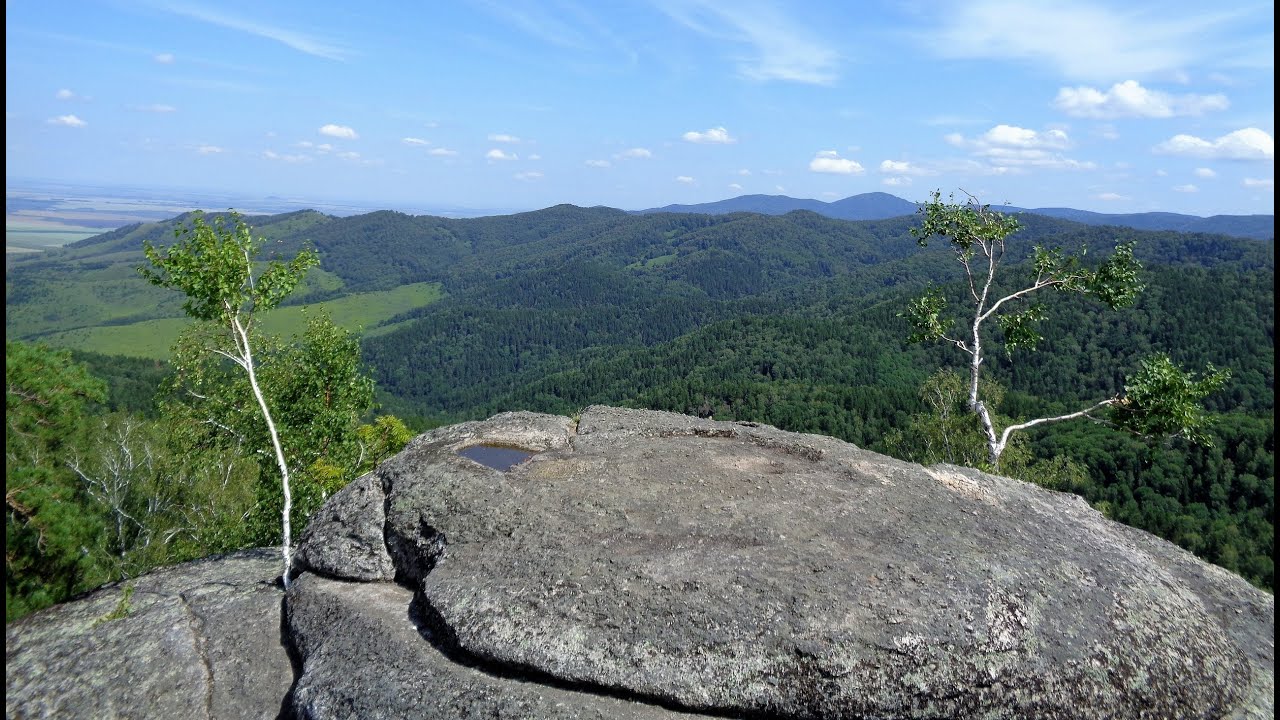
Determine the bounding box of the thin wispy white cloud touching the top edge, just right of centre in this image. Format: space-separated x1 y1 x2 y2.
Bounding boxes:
663 0 840 85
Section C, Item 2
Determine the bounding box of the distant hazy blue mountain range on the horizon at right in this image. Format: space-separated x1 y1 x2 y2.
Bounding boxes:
636 192 1275 240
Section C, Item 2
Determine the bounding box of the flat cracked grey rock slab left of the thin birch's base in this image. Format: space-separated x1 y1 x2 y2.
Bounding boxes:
5 550 293 720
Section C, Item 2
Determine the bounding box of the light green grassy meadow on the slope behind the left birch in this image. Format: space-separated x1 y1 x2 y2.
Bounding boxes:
40 283 443 360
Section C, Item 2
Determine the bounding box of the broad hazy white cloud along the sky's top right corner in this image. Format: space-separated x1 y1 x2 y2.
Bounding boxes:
920 0 1274 79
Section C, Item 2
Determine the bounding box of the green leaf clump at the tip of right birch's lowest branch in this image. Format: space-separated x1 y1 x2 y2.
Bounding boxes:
1111 355 1231 443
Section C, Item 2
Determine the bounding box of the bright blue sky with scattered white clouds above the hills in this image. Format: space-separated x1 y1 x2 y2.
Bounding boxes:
5 0 1275 215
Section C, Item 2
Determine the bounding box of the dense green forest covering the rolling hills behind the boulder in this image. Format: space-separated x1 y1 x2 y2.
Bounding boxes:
6 206 1275 617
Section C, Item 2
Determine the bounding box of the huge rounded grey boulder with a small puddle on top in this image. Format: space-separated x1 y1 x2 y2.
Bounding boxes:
8 407 1275 719
